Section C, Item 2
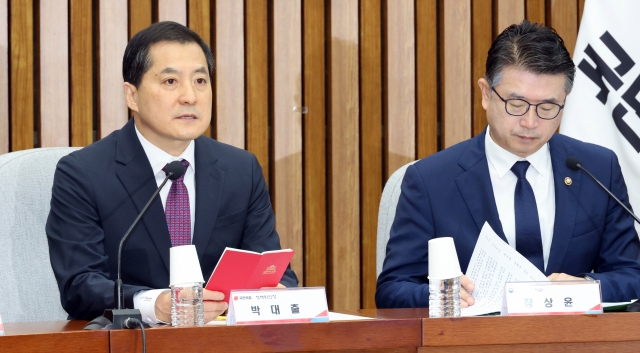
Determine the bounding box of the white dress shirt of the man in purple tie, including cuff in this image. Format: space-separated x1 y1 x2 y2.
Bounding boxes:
133 126 196 323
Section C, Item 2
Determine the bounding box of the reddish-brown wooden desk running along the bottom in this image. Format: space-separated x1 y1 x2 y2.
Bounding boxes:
0 309 640 353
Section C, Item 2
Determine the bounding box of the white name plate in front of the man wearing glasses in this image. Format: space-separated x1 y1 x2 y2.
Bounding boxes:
502 280 602 316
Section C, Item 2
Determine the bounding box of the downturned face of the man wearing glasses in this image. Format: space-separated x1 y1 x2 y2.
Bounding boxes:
478 66 567 158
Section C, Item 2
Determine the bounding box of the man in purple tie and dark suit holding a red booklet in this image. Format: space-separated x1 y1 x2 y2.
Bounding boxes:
46 22 298 322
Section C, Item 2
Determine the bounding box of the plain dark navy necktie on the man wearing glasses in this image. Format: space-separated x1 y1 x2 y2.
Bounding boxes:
511 161 544 273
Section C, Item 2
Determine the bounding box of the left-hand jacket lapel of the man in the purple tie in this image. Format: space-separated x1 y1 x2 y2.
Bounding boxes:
116 119 171 271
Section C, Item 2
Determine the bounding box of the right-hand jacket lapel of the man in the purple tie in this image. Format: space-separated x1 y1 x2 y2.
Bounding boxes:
192 137 224 262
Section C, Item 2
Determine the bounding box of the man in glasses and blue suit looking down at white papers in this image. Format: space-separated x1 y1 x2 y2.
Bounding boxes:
376 21 640 308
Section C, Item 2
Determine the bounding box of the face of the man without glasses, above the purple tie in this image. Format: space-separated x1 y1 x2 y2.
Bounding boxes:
124 42 212 156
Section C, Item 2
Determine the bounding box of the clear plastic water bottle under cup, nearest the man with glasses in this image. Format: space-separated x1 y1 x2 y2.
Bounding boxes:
429 277 460 318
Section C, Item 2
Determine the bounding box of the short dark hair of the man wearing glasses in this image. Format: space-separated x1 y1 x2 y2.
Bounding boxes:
484 20 576 94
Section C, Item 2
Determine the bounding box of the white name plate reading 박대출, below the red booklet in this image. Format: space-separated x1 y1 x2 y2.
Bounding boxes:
227 287 329 325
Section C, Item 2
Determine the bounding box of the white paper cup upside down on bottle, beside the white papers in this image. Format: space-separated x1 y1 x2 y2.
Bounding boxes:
427 237 462 280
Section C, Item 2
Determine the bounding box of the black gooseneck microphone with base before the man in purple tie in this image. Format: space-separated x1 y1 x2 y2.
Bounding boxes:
84 161 185 330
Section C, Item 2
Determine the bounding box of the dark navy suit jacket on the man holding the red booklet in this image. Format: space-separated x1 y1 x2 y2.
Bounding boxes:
46 119 298 319
